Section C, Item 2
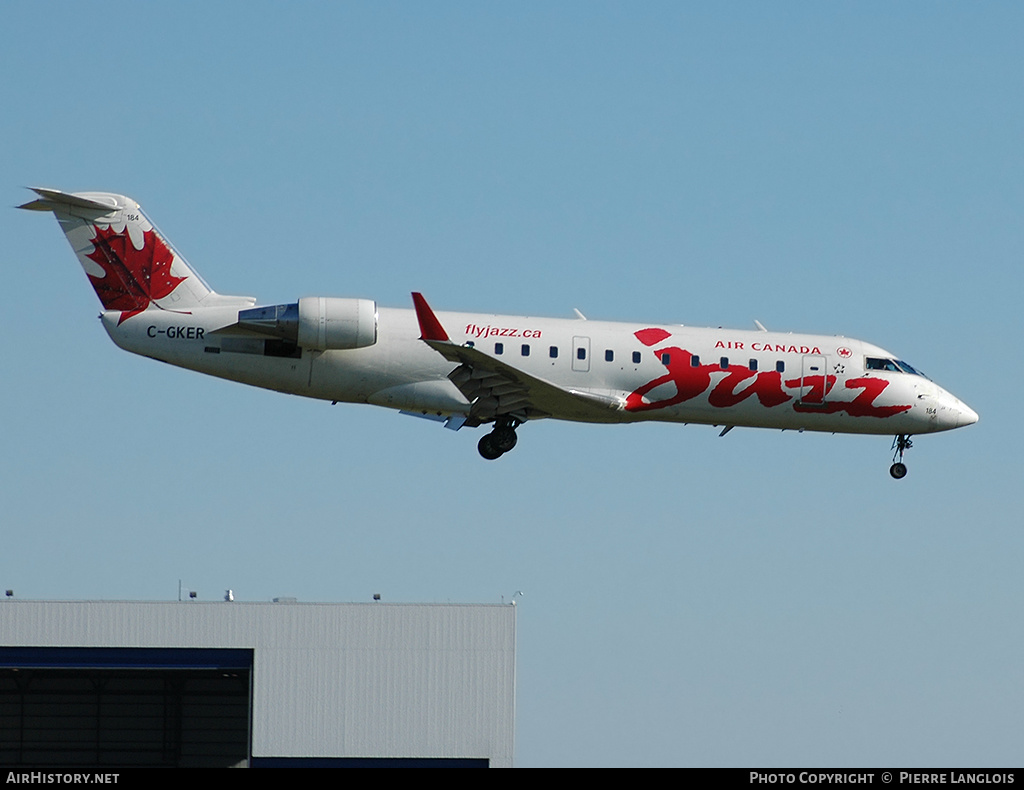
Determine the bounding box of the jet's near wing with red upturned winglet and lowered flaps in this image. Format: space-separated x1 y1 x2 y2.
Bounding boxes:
413 293 623 422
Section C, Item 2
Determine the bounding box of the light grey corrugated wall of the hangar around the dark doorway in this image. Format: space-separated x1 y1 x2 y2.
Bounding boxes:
0 599 515 767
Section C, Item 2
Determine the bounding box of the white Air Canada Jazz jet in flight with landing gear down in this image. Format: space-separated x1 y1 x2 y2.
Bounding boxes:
18 188 978 480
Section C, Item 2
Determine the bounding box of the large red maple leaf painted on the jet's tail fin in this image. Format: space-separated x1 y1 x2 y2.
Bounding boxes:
87 225 185 325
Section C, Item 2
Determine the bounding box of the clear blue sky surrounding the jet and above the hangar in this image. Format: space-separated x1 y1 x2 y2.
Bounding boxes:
0 2 1024 766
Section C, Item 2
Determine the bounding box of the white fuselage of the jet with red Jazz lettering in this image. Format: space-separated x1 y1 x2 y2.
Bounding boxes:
102 307 978 434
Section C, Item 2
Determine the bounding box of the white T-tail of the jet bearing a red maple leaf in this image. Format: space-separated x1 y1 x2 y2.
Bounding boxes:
18 186 254 324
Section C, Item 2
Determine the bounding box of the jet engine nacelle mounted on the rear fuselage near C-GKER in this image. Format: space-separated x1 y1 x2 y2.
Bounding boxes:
238 296 377 351
